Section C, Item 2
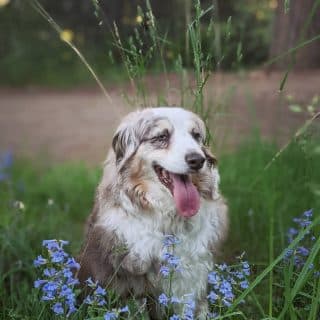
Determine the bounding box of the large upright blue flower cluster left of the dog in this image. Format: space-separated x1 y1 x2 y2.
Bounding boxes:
33 240 80 317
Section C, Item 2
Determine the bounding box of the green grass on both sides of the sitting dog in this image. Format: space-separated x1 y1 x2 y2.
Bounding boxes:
0 131 320 319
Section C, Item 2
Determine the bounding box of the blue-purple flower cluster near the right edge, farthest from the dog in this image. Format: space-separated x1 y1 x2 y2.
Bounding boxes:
284 209 319 274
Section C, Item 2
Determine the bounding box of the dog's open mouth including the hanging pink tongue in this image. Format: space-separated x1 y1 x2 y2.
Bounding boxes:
153 164 200 218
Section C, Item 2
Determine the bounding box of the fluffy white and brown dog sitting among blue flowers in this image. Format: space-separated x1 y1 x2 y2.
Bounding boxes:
78 107 228 319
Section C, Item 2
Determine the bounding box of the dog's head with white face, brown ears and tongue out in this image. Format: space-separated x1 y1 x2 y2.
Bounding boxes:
108 107 219 217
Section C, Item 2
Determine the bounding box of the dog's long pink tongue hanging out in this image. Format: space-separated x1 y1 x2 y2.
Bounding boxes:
170 173 200 217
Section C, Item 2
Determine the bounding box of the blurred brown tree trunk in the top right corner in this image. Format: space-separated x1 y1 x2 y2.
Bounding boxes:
270 0 320 69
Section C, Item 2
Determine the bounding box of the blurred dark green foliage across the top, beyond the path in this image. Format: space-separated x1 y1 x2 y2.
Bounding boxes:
0 0 275 86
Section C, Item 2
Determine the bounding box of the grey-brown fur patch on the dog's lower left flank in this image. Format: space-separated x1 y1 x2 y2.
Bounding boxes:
78 226 149 297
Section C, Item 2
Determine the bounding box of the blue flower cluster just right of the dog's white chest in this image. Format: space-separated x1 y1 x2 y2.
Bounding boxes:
207 261 250 307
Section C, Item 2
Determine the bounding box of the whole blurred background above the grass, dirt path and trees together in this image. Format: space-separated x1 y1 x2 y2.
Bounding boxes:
0 0 320 164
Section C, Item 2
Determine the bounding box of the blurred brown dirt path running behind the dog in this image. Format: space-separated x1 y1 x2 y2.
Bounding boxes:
0 70 320 164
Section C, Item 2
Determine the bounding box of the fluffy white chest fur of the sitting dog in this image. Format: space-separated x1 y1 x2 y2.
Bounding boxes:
99 200 220 299
